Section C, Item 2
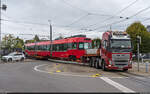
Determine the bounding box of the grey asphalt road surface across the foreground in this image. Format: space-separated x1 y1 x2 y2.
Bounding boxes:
0 61 150 92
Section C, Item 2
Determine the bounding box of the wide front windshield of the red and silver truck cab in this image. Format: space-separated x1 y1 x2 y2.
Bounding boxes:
110 39 131 49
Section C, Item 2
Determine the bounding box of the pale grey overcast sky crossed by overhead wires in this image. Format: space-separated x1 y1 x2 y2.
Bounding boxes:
2 0 150 40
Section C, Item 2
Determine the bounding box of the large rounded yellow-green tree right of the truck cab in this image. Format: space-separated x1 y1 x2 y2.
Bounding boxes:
126 22 150 53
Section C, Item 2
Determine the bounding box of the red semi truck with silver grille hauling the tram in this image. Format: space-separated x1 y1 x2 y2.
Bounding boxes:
81 31 132 71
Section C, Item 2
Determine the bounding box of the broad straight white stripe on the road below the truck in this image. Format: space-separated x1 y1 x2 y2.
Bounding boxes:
100 77 135 93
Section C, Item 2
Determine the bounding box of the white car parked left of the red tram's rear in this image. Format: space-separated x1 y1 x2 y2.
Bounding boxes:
2 52 25 62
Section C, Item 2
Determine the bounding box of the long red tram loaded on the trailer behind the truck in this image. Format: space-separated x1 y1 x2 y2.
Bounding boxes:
25 35 92 61
